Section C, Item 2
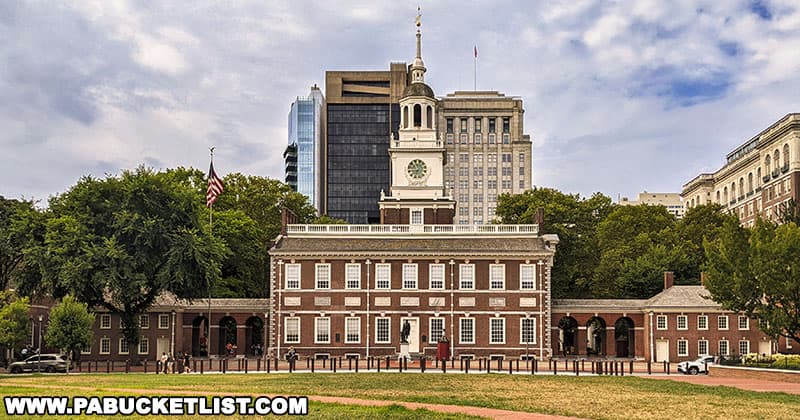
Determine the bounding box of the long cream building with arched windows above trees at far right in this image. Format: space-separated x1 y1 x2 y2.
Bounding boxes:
681 113 800 226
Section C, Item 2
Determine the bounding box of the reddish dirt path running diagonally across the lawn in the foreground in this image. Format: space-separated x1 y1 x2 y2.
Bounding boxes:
2 381 577 420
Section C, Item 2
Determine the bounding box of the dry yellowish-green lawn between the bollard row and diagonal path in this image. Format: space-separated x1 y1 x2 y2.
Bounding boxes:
0 373 800 420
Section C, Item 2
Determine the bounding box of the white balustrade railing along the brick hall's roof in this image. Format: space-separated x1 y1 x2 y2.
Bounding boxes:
286 225 539 235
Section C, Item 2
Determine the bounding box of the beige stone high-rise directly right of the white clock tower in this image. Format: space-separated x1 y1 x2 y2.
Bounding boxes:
439 91 533 224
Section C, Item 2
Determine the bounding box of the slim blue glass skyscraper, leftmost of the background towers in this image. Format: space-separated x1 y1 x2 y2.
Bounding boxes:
283 85 325 211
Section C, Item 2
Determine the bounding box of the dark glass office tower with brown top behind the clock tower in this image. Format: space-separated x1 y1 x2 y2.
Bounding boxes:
323 63 408 223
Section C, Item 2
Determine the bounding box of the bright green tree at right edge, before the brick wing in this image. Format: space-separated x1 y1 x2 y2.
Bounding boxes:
705 219 800 344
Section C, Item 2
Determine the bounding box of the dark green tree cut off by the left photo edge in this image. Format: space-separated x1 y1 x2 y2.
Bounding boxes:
0 196 44 296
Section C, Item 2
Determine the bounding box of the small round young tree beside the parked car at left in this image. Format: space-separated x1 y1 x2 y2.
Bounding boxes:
44 295 94 372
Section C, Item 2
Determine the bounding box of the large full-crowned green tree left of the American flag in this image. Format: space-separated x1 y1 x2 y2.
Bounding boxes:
41 167 226 363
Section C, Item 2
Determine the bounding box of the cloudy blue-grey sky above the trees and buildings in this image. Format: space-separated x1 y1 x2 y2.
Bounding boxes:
0 0 800 205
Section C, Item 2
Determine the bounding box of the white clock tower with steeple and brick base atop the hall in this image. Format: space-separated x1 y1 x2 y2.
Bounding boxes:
379 9 455 225
